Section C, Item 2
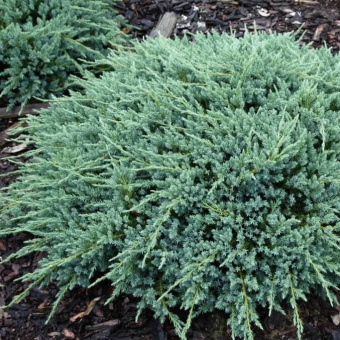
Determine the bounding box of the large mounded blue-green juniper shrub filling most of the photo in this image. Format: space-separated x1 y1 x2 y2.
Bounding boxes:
1 34 340 339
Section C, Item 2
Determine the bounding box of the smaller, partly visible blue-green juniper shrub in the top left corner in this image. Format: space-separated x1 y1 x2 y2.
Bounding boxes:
0 0 126 107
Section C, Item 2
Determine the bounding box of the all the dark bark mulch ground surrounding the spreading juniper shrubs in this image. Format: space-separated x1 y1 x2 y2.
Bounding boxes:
0 0 340 340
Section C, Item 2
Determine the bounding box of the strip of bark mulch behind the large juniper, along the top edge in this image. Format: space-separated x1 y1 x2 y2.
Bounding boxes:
118 0 340 52
